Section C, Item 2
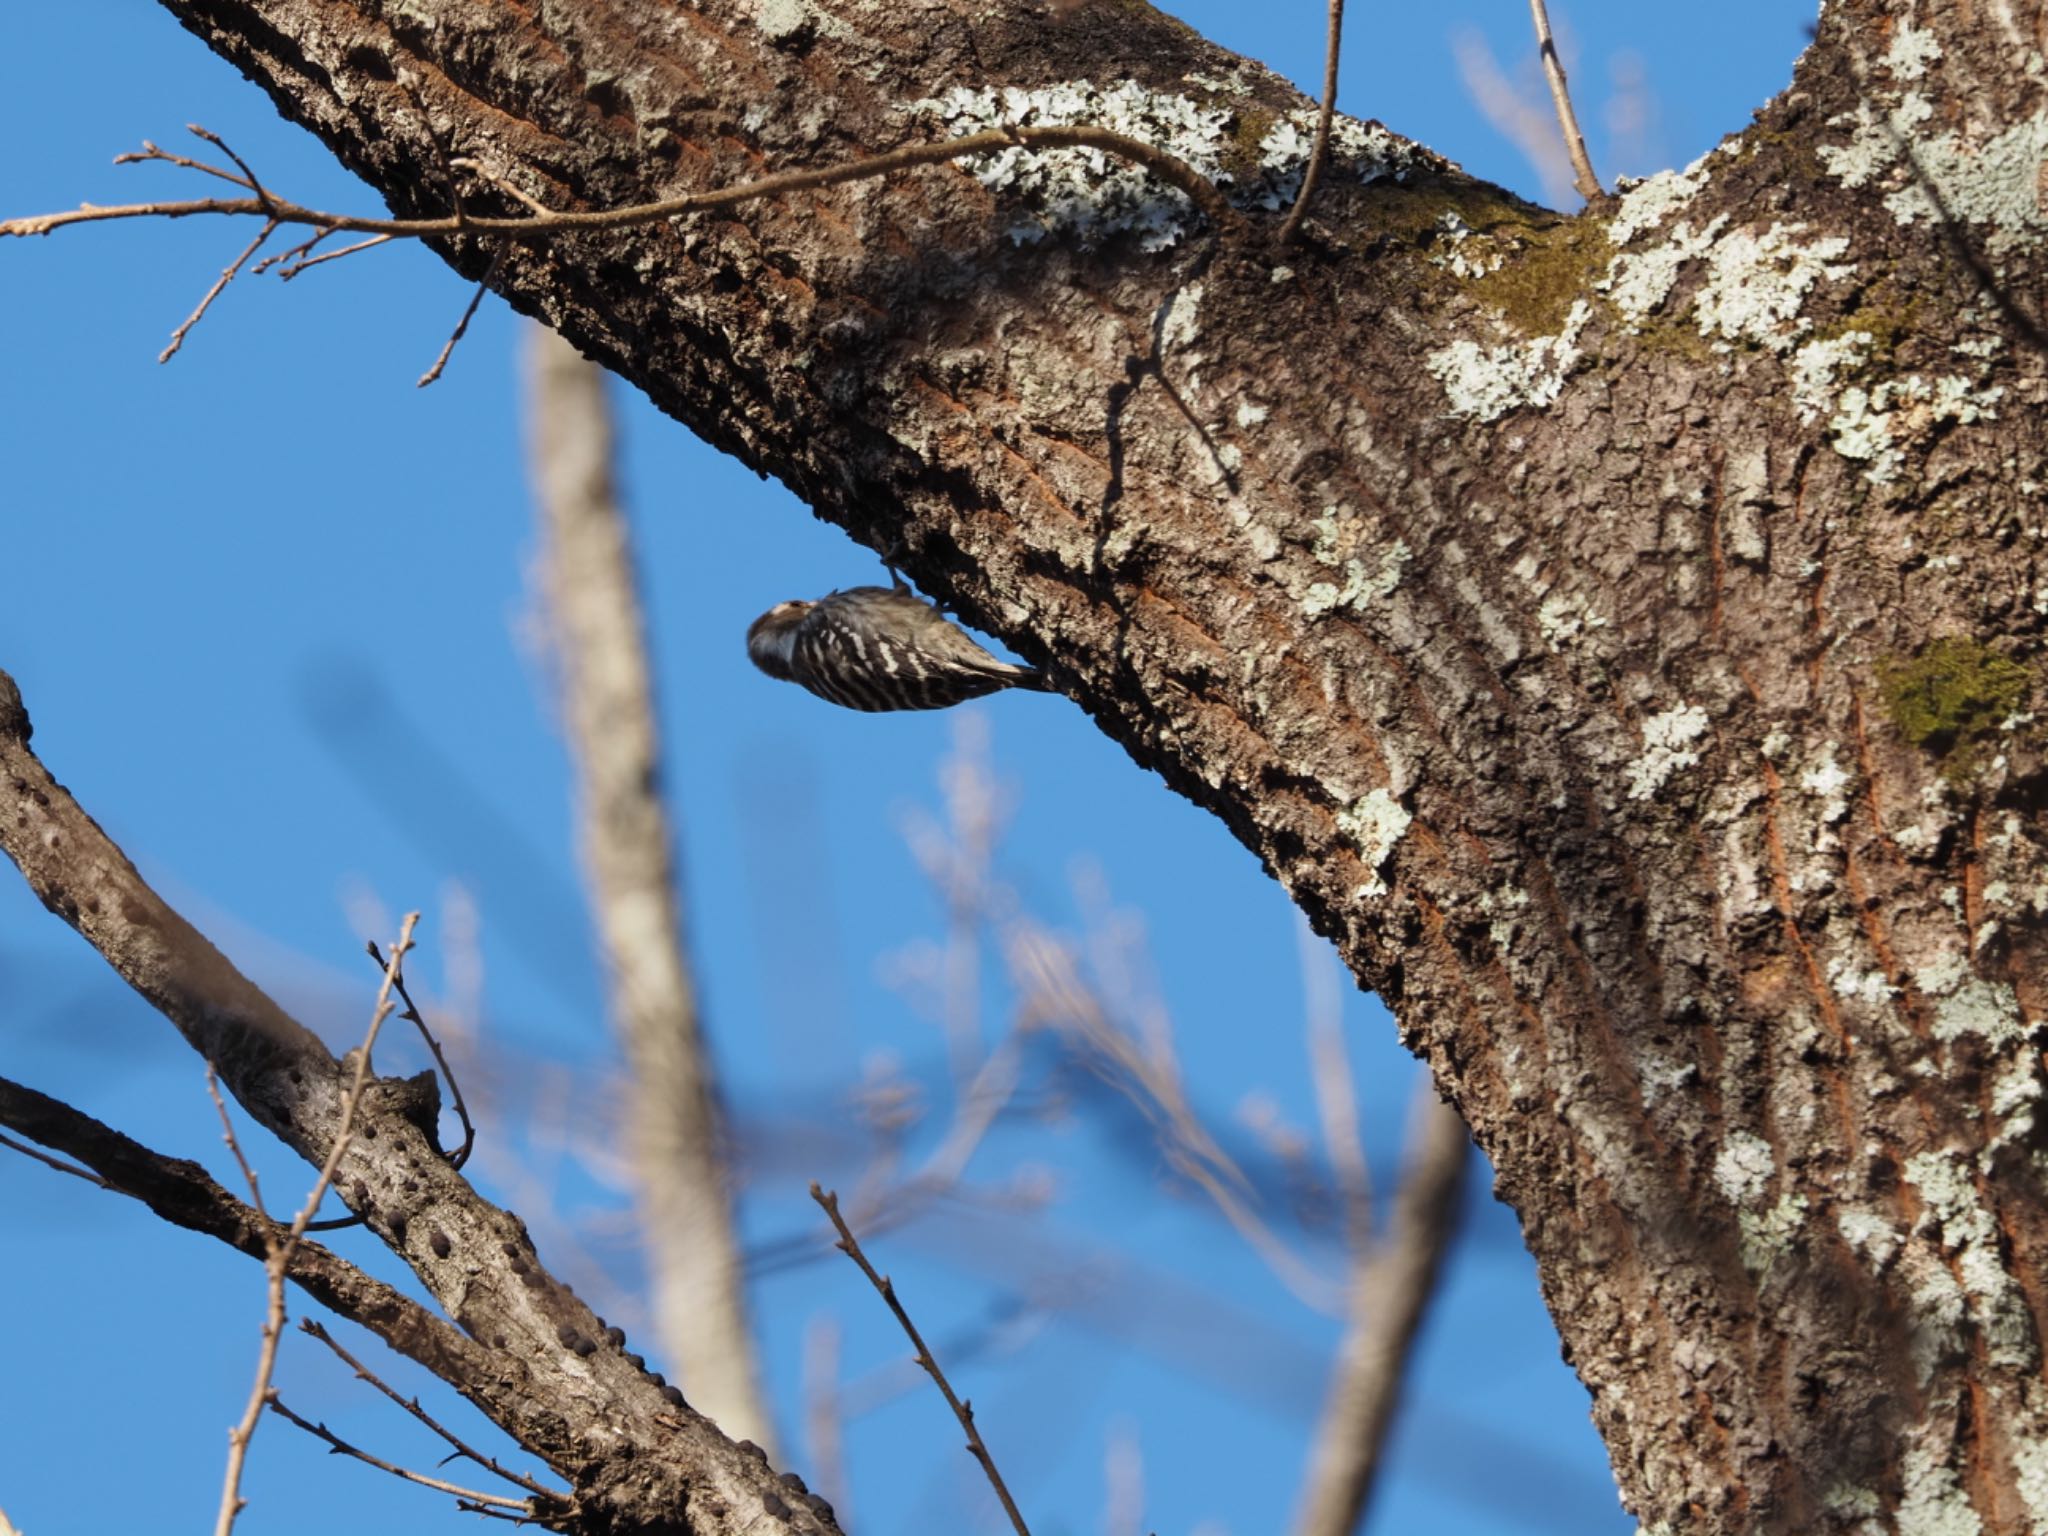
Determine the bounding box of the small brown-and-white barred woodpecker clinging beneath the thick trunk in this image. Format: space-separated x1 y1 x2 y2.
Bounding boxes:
748 586 1051 711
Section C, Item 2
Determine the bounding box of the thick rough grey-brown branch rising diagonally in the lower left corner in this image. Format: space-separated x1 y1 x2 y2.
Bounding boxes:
0 672 834 1536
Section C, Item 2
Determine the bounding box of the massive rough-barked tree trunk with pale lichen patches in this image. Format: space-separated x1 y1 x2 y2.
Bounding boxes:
144 0 2048 1534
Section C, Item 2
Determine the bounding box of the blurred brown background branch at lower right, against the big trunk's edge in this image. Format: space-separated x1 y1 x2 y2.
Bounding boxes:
1294 1077 1466 1536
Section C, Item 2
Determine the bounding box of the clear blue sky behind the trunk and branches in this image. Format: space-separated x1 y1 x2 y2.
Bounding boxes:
0 0 1812 1536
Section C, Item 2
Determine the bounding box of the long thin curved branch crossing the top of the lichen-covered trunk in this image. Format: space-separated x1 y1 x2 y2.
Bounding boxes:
0 123 1241 240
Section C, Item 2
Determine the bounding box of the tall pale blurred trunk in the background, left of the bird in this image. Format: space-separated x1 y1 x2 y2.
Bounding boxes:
526 326 774 1446
